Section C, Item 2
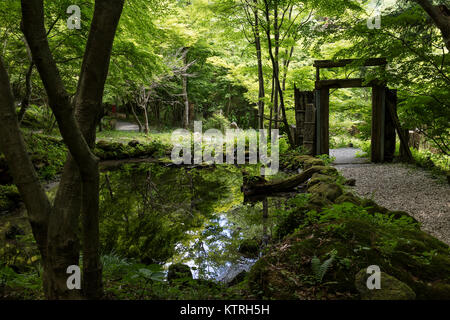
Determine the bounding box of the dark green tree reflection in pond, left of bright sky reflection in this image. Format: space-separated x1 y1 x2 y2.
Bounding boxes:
97 164 241 263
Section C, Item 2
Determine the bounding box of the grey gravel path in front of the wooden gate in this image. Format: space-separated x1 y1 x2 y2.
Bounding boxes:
334 151 450 245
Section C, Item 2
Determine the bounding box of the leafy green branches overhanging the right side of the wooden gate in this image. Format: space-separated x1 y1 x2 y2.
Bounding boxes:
332 1 450 154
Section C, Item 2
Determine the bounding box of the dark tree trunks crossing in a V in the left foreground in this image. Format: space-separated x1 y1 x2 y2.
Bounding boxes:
18 0 124 299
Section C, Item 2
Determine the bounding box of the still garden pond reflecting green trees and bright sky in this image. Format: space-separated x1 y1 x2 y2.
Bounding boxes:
100 163 289 282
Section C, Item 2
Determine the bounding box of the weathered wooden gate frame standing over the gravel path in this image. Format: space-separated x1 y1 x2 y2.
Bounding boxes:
295 58 403 162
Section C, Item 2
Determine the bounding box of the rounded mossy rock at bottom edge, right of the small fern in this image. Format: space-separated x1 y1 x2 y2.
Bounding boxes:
355 269 416 300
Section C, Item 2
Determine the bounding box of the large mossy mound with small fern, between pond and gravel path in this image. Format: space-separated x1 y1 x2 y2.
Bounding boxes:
248 203 450 299
